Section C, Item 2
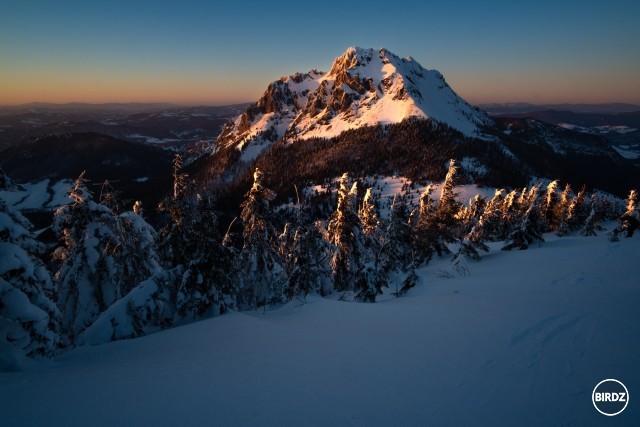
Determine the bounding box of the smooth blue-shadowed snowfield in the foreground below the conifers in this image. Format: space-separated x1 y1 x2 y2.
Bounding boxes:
0 229 640 427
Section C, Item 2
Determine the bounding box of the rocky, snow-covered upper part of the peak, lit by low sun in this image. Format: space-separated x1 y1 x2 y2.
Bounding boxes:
216 47 491 161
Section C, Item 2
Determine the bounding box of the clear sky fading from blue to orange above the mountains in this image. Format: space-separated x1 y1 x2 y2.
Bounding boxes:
0 0 640 105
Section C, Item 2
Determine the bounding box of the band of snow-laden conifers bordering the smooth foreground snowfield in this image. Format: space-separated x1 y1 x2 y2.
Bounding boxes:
0 161 638 368
